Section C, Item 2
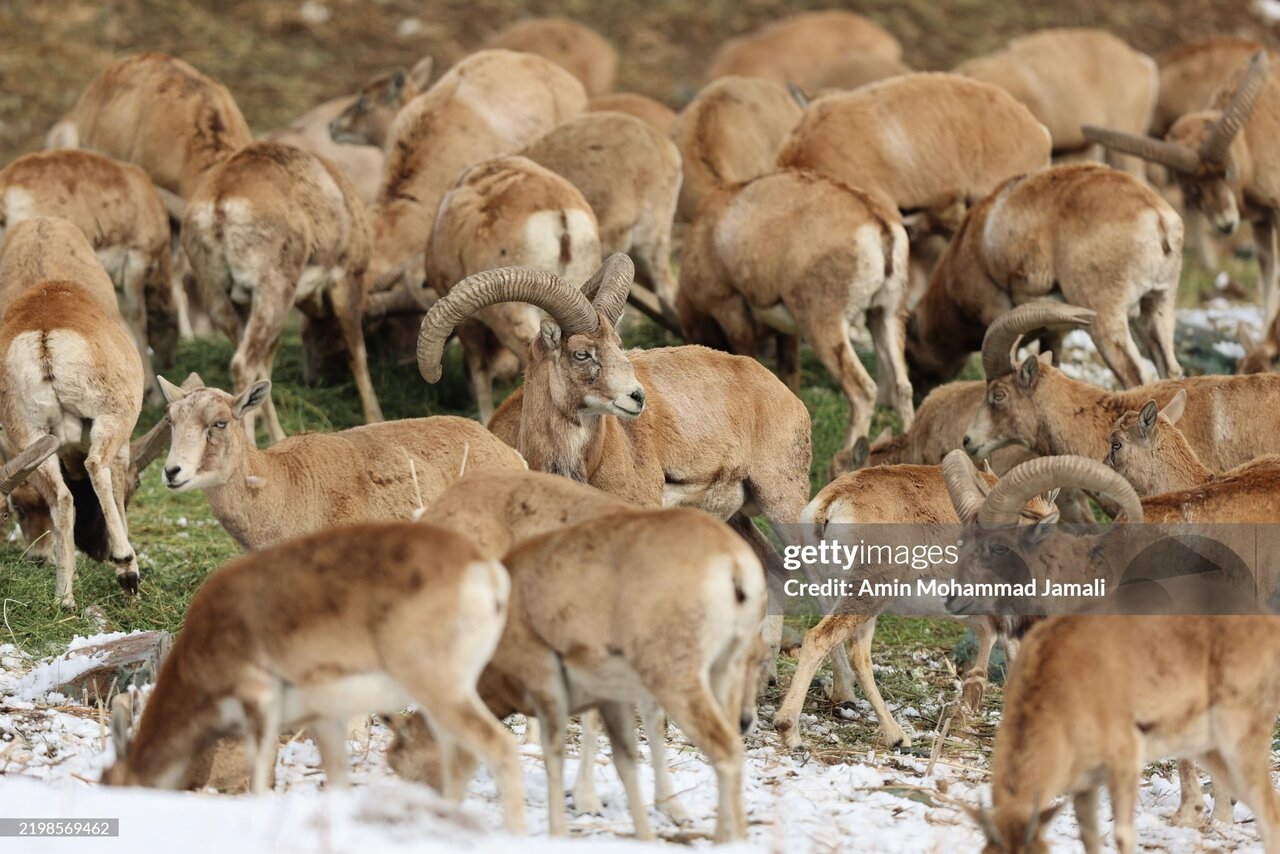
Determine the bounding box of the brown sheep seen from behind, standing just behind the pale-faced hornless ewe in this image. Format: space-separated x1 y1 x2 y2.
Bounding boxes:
182 142 383 442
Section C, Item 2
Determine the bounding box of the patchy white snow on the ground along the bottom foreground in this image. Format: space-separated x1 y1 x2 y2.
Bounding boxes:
0 636 1260 854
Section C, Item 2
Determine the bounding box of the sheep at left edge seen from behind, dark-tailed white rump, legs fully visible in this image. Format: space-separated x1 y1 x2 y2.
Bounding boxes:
0 216 146 608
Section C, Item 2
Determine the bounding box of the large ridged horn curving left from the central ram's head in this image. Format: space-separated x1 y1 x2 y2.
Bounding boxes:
417 266 600 383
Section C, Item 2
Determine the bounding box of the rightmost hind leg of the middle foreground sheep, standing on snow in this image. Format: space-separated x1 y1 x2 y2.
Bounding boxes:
653 679 746 842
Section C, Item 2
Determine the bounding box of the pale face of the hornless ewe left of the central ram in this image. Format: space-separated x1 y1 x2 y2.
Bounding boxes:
164 388 243 492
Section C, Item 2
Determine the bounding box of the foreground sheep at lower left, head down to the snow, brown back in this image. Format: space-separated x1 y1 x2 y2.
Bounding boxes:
102 522 525 832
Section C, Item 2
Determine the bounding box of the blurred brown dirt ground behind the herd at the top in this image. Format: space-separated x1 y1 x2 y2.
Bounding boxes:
0 0 1276 163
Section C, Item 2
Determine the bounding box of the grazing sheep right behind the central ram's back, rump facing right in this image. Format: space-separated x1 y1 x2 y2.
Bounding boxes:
678 169 914 448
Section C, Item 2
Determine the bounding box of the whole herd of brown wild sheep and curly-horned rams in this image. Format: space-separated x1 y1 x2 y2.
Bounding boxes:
0 12 1280 851
